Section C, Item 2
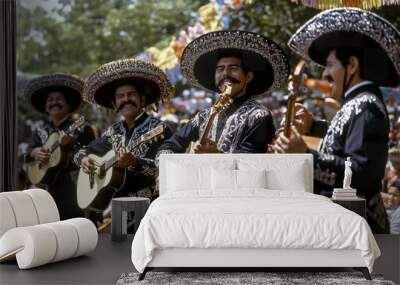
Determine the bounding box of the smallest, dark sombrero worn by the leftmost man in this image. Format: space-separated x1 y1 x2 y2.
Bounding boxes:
24 73 83 113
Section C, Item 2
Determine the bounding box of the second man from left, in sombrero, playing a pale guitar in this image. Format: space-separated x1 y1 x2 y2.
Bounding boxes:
74 59 172 210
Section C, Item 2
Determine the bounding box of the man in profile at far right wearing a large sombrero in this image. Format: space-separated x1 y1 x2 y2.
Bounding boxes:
274 8 400 233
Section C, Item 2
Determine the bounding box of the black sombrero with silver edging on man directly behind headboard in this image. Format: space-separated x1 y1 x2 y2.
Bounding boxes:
181 31 290 95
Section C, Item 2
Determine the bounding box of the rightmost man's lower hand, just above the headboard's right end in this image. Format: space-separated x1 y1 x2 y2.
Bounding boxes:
272 126 308 153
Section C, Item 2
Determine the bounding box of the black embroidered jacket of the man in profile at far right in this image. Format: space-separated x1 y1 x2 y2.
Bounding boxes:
311 81 389 200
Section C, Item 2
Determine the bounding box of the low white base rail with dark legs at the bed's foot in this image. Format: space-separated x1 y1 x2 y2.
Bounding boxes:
139 248 371 280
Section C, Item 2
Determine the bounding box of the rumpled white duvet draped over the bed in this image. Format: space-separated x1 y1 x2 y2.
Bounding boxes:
132 189 380 272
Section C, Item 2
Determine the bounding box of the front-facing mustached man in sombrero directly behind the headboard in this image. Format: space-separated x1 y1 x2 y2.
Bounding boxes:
158 31 289 155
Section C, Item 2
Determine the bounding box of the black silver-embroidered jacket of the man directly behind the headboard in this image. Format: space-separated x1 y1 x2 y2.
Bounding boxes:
158 93 275 154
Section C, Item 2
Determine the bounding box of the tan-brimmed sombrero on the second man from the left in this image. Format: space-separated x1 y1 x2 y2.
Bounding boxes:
83 59 172 108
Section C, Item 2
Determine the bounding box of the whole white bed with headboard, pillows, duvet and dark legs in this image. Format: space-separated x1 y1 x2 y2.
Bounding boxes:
132 154 380 278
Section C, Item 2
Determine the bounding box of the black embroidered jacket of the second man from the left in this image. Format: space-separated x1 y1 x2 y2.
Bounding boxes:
74 113 171 195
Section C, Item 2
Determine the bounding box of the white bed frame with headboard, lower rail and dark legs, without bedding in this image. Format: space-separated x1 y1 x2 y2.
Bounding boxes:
139 154 371 280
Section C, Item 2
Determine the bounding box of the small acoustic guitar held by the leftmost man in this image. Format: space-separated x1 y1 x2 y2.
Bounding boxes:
27 116 85 186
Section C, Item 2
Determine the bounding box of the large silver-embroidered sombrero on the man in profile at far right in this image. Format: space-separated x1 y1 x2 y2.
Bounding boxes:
288 8 400 86
